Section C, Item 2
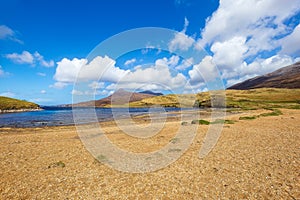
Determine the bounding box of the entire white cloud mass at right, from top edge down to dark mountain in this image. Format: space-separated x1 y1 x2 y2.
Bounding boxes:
190 0 300 85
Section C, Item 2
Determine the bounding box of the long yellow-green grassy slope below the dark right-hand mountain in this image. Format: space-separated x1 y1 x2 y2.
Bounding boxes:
129 88 300 110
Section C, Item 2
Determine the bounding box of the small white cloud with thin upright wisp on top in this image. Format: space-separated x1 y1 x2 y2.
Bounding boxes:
168 18 195 51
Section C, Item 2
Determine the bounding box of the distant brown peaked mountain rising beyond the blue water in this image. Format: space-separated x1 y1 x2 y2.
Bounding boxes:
70 89 157 107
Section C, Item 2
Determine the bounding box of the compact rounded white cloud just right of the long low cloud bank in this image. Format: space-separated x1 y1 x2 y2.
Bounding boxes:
188 56 219 85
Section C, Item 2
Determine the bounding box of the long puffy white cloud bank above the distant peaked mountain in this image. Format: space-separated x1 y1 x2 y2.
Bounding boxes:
51 55 186 94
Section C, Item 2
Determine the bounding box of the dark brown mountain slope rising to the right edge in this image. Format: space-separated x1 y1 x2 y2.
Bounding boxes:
227 62 300 90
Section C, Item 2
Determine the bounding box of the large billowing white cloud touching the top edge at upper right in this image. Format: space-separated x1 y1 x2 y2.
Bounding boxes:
199 0 300 50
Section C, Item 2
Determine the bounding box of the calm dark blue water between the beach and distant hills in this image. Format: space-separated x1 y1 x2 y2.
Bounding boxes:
0 107 186 127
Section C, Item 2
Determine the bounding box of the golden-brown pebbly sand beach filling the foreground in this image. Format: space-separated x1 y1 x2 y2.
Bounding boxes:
0 109 300 199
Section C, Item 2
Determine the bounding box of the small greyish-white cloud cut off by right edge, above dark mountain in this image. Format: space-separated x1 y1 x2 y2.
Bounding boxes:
280 25 300 55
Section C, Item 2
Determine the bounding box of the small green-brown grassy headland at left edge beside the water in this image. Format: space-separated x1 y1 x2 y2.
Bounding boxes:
0 97 39 111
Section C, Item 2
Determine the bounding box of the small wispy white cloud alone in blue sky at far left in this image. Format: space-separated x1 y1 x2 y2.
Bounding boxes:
5 51 54 67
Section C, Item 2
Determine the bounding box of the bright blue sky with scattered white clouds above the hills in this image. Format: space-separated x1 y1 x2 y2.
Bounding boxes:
0 0 300 105
